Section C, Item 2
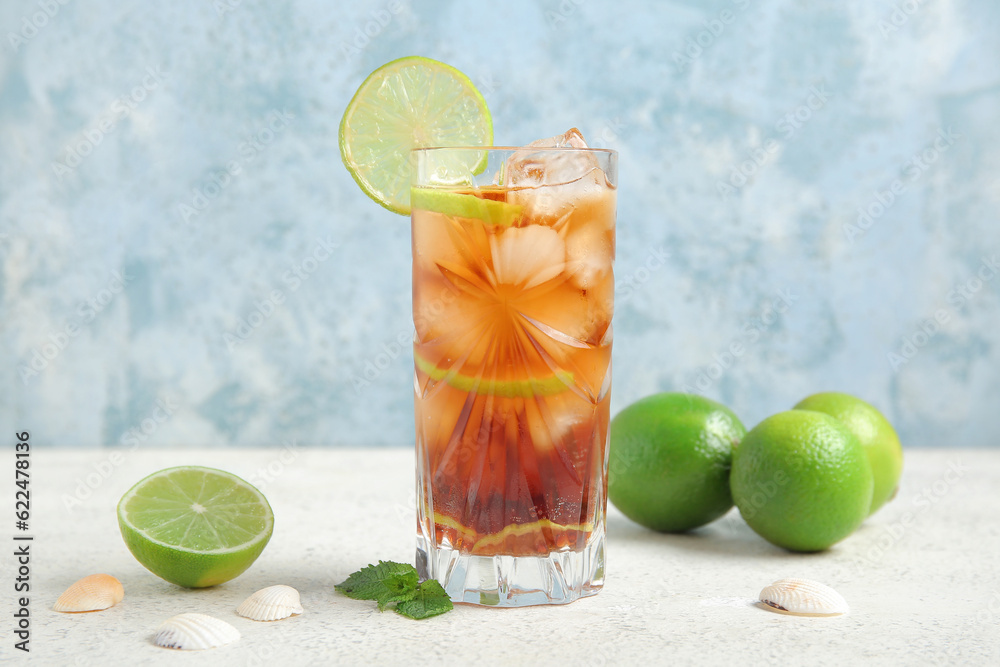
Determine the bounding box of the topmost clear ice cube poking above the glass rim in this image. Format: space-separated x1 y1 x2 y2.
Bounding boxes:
501 127 604 188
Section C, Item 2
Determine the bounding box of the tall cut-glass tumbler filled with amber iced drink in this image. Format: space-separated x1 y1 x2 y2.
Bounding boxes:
411 147 617 607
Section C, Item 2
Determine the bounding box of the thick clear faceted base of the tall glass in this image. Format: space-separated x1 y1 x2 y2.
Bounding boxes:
417 526 604 607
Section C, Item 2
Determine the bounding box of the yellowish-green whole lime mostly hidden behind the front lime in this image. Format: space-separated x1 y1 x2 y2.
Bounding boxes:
795 391 903 515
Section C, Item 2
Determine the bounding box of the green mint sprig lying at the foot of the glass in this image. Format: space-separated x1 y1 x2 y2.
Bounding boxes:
335 560 454 619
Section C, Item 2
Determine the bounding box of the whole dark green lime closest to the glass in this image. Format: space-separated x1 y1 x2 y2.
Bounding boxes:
608 393 746 532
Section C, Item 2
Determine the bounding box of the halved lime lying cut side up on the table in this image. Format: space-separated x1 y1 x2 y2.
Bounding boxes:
118 466 274 588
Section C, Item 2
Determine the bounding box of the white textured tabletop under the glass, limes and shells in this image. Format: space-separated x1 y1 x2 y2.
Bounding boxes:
0 448 1000 666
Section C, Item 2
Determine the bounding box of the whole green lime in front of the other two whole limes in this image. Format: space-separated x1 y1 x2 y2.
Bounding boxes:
730 410 873 551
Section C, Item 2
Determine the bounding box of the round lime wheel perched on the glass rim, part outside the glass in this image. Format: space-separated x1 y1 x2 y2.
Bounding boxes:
340 56 493 215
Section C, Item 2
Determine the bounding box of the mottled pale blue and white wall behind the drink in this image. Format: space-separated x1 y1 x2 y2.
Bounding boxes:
0 0 1000 446
